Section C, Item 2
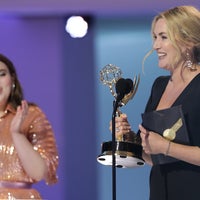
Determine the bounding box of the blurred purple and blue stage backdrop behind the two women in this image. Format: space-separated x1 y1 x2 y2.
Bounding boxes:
0 13 169 200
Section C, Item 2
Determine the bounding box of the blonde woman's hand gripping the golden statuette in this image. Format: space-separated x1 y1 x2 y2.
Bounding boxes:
109 113 131 138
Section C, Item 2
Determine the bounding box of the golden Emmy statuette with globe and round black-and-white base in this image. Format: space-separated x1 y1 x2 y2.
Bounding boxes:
97 64 145 168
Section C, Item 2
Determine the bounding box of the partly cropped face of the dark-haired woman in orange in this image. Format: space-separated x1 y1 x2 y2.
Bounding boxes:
0 61 13 110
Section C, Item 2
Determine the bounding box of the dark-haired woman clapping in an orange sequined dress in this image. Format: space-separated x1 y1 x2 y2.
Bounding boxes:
0 54 58 200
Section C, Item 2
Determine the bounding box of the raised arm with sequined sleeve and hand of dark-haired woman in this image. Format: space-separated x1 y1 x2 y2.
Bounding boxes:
10 101 58 183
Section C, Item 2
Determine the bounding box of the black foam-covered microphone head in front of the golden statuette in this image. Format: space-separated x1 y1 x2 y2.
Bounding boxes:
115 78 133 101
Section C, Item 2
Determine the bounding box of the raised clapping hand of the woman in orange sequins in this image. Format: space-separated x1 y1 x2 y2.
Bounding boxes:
10 100 28 134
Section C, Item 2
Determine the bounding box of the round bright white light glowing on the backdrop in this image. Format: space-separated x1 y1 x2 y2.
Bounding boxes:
65 16 88 38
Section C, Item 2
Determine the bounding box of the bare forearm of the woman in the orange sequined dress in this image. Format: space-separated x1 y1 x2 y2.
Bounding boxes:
13 133 47 181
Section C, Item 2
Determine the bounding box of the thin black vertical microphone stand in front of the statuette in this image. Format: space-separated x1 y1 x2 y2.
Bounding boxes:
112 98 119 200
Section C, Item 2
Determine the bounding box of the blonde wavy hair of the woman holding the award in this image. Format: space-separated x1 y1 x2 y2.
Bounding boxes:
143 6 200 67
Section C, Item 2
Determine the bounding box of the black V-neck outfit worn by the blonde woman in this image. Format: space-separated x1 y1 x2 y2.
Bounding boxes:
145 74 200 200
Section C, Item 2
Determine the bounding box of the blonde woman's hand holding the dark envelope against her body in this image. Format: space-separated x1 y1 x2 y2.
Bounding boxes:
139 125 169 154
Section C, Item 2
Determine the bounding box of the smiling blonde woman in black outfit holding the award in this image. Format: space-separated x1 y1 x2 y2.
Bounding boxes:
110 6 200 200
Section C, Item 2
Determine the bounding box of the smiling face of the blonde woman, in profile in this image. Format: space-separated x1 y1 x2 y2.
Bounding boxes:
153 18 183 71
